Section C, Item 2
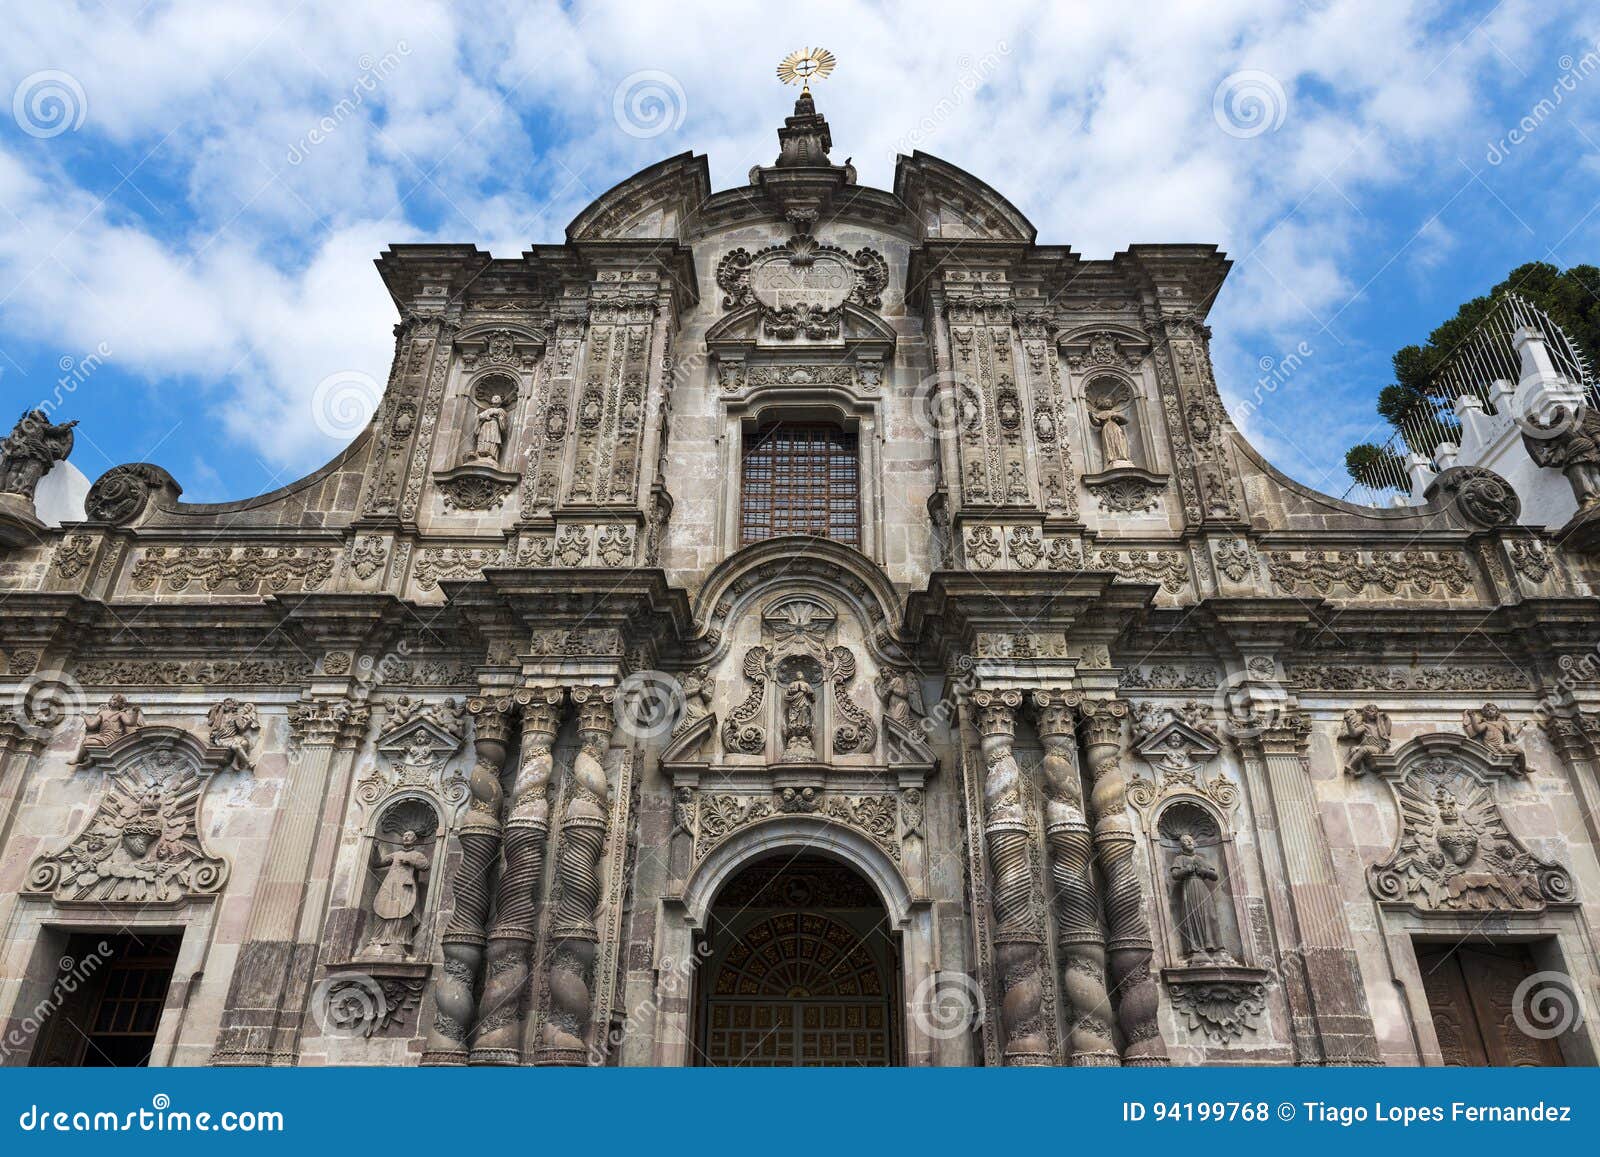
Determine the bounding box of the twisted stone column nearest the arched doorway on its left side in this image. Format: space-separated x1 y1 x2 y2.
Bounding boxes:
536 687 616 1064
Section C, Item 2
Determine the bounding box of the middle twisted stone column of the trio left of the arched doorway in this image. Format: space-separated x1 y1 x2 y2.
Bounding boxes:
472 687 566 1064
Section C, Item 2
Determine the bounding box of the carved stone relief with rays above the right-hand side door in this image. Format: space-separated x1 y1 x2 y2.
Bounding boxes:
1366 755 1573 912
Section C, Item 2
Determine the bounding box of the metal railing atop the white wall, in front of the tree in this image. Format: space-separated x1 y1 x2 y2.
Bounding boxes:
1341 293 1600 506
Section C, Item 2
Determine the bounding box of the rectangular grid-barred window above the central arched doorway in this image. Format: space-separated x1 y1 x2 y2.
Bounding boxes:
739 422 861 547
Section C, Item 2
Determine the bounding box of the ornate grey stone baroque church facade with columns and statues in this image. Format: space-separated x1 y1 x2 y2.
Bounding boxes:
0 93 1600 1066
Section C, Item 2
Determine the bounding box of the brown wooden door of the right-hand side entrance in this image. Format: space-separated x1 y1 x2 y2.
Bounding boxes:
1416 944 1565 1066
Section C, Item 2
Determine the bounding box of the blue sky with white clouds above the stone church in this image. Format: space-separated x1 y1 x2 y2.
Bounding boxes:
0 0 1600 501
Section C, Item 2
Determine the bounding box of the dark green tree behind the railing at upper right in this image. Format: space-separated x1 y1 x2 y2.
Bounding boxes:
1344 261 1600 488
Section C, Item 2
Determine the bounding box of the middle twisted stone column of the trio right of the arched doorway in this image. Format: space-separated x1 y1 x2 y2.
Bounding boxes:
1034 691 1122 1066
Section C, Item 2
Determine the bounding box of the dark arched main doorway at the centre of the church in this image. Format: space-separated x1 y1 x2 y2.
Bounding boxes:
694 853 904 1067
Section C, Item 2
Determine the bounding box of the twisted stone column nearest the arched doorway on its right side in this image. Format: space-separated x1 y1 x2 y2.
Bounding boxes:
973 691 1053 1064
